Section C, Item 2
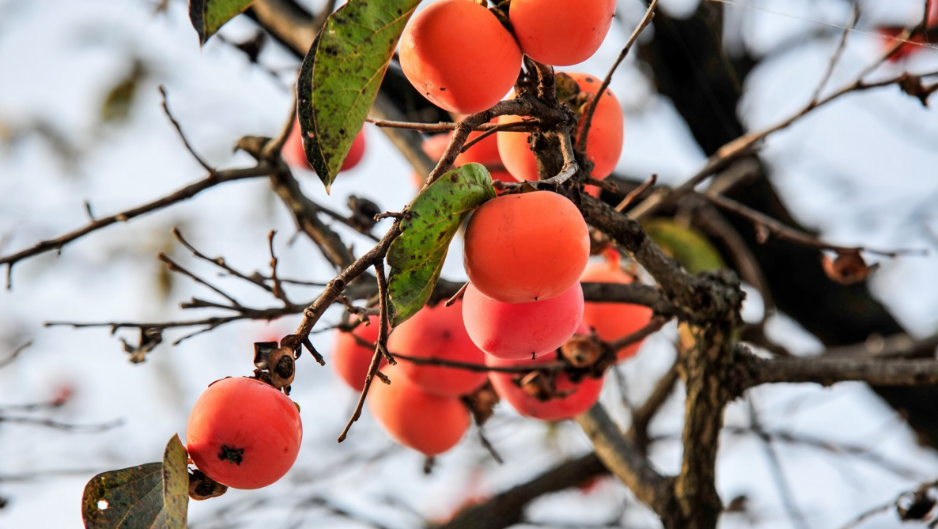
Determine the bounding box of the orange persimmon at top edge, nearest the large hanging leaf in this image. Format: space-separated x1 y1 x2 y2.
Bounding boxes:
400 0 521 114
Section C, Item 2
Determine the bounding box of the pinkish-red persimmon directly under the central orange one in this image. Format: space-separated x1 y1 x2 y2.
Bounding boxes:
463 283 583 359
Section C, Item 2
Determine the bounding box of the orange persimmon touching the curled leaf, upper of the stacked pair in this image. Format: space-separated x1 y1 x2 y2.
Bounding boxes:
464 191 590 303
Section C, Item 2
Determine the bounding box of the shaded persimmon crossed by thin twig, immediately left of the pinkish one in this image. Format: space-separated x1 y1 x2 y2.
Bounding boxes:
388 301 487 397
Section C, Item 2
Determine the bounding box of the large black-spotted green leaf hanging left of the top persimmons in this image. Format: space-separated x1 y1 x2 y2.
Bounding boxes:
297 0 420 193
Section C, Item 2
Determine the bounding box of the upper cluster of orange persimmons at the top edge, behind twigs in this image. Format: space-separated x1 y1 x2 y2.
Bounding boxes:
400 0 623 194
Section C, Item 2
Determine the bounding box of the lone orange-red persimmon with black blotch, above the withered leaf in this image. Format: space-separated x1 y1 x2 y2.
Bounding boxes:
186 378 303 489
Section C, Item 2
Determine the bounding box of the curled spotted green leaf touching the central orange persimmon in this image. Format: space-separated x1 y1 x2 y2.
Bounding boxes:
388 163 495 326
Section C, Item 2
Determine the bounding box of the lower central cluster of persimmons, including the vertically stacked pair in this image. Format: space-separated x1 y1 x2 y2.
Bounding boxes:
332 191 651 456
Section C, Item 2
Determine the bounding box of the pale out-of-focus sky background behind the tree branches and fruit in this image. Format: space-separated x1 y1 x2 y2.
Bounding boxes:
0 0 938 528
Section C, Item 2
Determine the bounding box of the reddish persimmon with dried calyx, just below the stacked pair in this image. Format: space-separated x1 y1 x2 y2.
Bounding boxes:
485 355 603 421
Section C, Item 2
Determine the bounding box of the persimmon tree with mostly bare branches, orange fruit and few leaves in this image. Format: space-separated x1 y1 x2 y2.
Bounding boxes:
0 0 938 528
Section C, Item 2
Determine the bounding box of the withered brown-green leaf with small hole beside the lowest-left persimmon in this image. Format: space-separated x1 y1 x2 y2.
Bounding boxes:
81 435 189 529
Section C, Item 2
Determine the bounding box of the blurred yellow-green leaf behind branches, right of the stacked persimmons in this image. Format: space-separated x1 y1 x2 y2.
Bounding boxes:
642 218 726 274
